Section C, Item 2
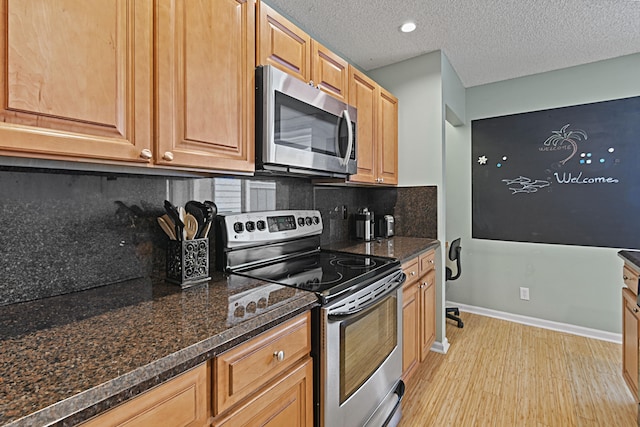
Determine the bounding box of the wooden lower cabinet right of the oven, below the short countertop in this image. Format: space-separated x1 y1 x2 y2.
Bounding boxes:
402 250 436 380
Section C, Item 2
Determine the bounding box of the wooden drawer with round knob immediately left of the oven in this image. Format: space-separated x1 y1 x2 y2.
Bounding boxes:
213 312 311 415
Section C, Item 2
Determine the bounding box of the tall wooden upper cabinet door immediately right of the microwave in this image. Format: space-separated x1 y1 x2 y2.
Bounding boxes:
349 67 379 183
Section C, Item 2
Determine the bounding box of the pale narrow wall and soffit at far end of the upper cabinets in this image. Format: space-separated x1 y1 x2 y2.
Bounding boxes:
370 51 465 352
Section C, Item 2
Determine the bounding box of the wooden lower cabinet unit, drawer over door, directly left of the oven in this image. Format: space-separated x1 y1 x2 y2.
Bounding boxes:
212 312 313 427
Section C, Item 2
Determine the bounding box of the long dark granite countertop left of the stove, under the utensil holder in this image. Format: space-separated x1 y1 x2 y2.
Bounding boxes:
0 272 317 426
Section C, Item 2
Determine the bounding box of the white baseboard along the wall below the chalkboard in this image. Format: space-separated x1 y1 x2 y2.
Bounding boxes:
446 301 622 344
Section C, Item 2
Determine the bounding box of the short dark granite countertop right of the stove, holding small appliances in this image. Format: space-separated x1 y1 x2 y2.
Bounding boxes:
323 236 440 263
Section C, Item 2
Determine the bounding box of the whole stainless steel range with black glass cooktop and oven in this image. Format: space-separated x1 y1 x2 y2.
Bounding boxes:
216 211 405 427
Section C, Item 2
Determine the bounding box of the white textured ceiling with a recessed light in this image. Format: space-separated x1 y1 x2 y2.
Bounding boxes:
267 0 640 87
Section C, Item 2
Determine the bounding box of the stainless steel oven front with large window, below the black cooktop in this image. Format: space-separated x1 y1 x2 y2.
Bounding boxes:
320 272 404 427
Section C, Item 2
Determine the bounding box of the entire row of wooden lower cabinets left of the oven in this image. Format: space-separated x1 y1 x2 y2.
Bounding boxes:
82 312 313 427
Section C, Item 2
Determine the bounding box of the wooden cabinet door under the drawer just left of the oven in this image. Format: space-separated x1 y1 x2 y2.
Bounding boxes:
212 357 313 427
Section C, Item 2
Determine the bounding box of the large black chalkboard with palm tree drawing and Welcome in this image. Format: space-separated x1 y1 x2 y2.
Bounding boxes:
471 97 640 249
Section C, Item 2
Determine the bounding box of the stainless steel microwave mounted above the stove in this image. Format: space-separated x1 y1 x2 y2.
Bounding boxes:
256 65 358 177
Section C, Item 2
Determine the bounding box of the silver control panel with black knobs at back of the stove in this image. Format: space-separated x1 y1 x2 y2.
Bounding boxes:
218 210 322 248
